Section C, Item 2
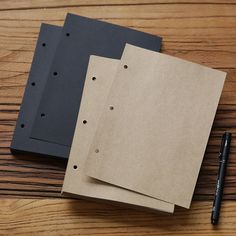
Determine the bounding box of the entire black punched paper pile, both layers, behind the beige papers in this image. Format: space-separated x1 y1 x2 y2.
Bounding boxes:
11 14 161 159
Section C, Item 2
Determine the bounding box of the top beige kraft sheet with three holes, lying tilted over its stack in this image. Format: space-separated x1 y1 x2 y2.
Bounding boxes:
86 45 226 208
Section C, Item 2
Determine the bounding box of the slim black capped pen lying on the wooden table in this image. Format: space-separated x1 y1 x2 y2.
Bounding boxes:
211 132 231 225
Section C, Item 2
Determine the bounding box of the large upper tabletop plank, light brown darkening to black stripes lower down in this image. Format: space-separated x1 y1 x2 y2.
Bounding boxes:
0 0 236 199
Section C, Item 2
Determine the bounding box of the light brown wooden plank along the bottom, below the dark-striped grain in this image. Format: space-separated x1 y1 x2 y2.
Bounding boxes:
0 199 236 236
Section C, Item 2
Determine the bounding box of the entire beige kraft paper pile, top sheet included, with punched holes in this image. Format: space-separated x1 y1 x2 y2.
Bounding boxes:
63 44 226 212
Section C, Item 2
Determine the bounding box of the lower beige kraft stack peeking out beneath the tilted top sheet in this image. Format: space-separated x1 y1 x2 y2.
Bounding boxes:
62 56 174 213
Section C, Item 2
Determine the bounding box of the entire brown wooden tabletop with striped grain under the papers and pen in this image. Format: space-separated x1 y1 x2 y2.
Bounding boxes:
0 0 236 236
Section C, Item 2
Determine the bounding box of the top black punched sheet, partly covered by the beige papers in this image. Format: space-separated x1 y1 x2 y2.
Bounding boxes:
31 14 161 148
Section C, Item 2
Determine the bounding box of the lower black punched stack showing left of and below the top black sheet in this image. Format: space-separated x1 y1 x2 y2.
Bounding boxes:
10 24 69 157
